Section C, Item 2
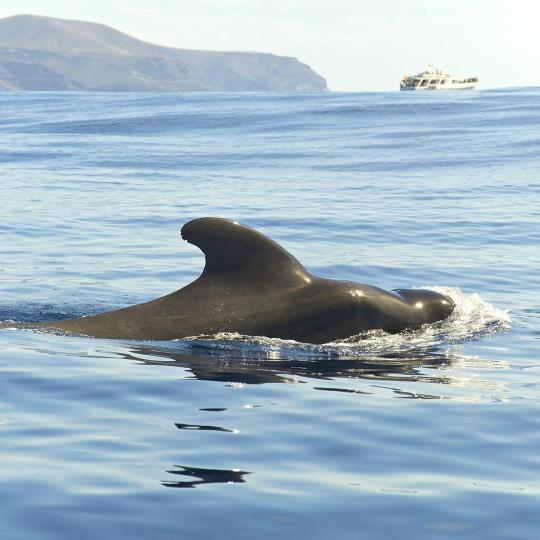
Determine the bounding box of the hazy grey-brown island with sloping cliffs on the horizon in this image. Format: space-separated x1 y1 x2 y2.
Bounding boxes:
0 15 328 92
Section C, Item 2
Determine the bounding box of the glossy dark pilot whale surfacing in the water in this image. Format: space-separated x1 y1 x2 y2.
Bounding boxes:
33 217 454 344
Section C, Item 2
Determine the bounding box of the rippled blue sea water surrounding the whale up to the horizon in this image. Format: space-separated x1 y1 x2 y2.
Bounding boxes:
0 88 540 540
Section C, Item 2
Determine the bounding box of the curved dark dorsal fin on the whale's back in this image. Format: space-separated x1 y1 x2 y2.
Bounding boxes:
182 217 309 285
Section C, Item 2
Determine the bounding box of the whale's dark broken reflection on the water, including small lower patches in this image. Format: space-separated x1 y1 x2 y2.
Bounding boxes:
132 342 455 488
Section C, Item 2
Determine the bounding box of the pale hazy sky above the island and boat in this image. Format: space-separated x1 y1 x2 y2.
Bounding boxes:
0 0 540 91
